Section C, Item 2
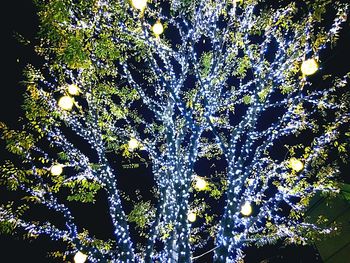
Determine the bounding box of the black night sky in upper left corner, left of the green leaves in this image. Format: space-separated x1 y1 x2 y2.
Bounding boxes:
0 0 37 127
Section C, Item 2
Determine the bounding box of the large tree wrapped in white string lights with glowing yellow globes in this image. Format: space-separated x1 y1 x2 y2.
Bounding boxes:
0 0 350 262
